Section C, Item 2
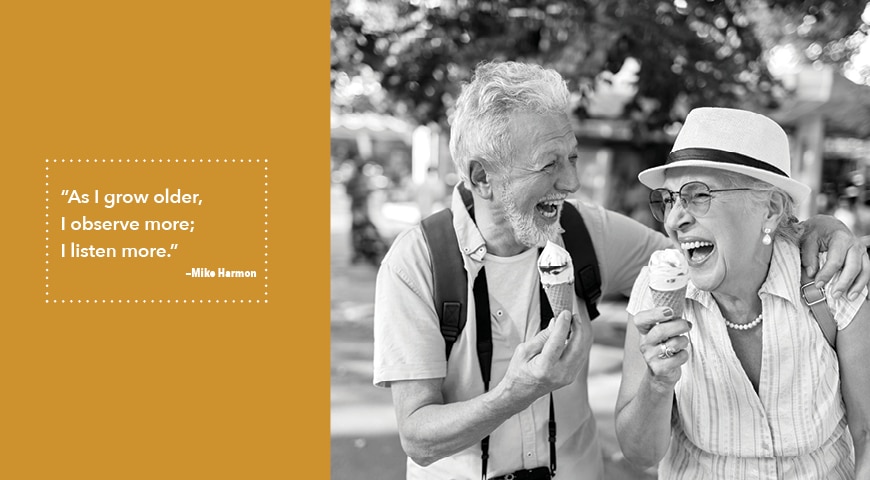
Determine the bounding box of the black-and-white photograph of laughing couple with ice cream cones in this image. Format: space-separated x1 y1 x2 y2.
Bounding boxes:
329 0 870 480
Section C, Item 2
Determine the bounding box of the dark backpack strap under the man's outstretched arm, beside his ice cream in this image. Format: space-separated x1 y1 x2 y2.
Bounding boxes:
560 202 601 320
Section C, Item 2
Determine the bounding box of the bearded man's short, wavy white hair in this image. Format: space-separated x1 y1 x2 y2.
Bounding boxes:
450 62 570 185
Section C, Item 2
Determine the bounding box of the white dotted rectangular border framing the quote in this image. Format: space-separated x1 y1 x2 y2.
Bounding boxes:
45 158 269 305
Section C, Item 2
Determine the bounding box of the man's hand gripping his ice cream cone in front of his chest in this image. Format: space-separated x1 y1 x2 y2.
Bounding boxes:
499 310 592 405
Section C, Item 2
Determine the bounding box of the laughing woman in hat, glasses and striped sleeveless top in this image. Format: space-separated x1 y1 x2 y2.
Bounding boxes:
616 108 870 479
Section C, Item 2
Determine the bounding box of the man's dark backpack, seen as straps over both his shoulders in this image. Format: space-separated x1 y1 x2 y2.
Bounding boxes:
421 192 601 358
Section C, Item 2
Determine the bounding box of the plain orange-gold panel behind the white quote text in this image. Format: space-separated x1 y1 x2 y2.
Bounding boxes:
0 0 329 480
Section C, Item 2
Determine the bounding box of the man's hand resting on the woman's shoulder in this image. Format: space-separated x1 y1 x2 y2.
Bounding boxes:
801 215 870 298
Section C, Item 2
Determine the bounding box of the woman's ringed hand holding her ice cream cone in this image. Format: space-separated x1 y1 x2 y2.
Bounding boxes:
634 307 692 390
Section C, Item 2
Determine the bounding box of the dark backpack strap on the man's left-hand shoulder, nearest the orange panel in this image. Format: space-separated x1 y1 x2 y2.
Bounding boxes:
420 209 468 358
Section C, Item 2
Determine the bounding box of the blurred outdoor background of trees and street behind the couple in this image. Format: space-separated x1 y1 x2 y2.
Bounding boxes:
330 0 870 480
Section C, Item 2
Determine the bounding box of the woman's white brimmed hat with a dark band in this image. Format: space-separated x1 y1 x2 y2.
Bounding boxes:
637 108 810 203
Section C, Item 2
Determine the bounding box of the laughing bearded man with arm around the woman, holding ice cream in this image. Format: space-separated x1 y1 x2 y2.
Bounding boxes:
374 62 870 479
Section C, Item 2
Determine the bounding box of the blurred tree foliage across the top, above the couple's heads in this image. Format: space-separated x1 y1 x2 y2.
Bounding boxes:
332 0 867 129
